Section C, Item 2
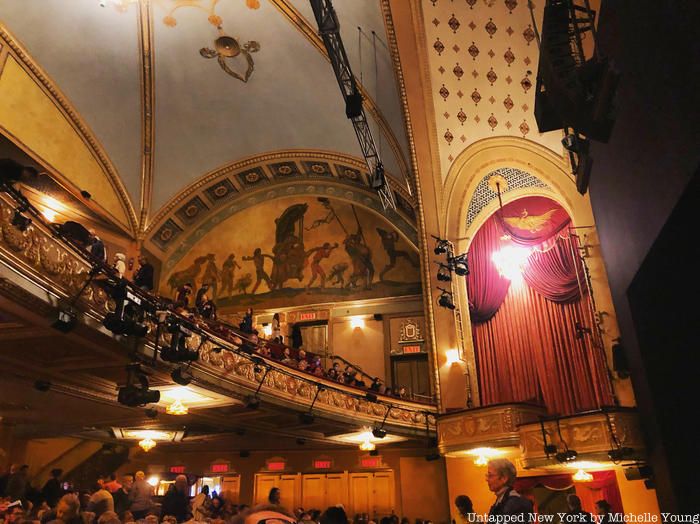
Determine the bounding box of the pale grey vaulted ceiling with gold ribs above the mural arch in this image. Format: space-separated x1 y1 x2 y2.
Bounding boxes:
0 0 409 237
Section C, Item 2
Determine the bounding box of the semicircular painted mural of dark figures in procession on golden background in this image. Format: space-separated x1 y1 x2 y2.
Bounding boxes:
160 195 421 312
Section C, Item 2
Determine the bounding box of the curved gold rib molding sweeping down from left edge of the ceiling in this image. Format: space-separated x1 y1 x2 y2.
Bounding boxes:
0 23 138 234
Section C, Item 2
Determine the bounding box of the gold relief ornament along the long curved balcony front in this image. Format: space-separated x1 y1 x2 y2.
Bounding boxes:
0 195 437 435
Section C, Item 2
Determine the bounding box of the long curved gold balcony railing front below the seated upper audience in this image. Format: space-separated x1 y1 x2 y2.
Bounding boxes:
0 191 437 434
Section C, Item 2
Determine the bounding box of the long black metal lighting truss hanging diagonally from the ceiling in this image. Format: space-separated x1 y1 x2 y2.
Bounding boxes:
310 0 396 210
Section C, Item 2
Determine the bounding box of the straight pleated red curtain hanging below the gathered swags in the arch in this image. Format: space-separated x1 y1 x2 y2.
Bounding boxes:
472 285 612 414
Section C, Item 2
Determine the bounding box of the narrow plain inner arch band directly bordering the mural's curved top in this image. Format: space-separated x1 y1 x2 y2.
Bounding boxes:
163 180 418 273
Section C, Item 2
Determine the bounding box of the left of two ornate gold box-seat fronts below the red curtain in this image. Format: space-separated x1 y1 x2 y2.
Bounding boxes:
438 404 546 454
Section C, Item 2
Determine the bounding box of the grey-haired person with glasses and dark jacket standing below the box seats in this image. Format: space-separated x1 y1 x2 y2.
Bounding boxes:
486 459 534 522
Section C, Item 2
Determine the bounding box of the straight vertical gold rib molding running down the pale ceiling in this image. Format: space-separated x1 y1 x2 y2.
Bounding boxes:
138 0 156 235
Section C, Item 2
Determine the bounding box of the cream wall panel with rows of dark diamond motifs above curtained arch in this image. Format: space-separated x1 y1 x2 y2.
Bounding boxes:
421 0 562 179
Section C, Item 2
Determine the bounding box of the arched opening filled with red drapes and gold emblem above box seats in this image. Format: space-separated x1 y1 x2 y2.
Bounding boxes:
467 196 614 414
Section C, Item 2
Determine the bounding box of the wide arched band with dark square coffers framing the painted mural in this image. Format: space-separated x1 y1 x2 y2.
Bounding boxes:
147 151 417 256
